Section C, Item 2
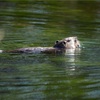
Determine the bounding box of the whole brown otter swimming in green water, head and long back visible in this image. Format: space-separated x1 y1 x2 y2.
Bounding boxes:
0 37 80 53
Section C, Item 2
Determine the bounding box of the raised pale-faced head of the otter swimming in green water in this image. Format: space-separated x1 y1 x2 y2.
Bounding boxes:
54 37 80 49
